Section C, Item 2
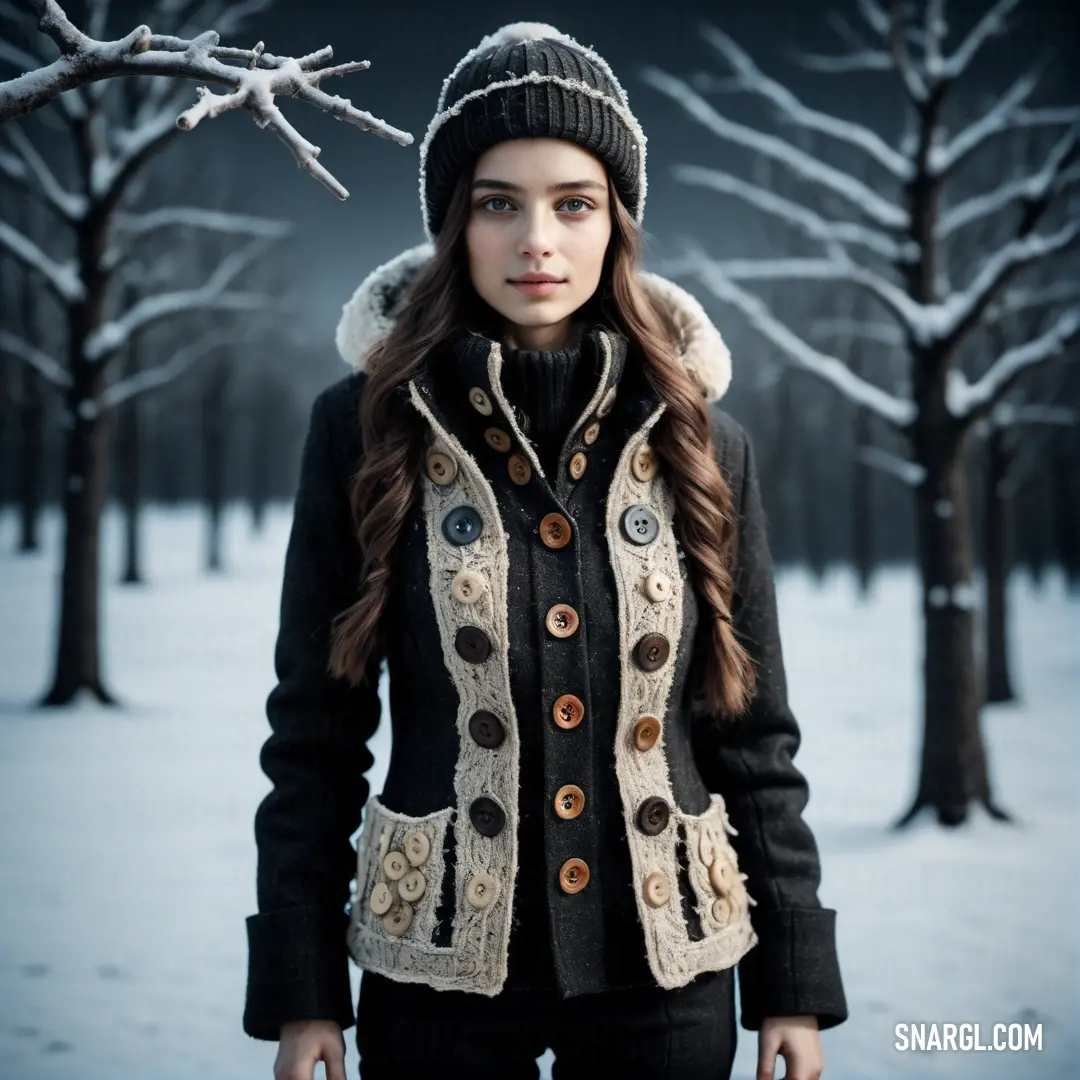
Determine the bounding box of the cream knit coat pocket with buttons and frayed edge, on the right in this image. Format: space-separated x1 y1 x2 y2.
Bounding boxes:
678 794 757 936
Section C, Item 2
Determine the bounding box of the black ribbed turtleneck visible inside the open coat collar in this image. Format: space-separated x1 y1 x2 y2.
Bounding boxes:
501 338 599 476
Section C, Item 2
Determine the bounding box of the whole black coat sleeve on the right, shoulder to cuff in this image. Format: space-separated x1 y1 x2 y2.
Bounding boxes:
698 410 848 1031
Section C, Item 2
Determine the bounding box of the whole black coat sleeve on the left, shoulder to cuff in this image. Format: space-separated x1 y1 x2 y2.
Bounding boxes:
243 384 380 1040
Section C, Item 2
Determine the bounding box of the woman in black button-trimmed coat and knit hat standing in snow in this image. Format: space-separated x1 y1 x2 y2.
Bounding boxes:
244 24 847 1080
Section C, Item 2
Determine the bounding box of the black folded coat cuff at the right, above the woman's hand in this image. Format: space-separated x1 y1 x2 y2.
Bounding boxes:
739 907 848 1031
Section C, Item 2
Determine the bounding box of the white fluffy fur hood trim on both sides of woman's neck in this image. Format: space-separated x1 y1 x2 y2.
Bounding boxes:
334 243 731 401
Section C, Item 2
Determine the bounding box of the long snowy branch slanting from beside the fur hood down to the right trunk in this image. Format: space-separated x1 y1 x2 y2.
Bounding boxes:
665 242 916 430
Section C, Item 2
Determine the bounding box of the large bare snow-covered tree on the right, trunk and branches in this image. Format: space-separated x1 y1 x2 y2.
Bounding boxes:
645 0 1080 825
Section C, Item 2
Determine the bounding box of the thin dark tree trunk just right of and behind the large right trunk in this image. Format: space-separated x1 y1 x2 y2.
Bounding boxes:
983 428 1016 703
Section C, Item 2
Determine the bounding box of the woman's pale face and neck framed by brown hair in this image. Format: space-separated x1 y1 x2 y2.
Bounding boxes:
465 138 611 349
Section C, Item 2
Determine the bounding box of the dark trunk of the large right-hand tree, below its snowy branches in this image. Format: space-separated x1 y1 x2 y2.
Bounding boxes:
897 434 1007 826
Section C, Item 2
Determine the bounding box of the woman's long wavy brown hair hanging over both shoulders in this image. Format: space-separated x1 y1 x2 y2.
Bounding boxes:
328 170 755 720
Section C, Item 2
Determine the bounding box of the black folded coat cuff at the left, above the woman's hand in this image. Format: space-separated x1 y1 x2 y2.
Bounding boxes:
244 905 356 1041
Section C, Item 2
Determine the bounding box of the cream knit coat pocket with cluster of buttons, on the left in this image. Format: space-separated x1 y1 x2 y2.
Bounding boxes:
349 795 454 945
